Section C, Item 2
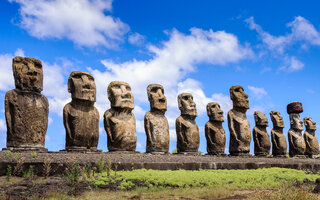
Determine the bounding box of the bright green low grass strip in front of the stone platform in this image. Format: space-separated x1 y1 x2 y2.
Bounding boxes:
89 168 320 190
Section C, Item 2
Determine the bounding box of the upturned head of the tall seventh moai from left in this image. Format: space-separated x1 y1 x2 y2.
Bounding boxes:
230 85 249 109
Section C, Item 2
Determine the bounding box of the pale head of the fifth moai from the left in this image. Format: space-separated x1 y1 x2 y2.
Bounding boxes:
178 93 197 117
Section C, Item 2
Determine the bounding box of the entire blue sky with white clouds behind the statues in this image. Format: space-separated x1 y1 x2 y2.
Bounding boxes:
0 0 320 153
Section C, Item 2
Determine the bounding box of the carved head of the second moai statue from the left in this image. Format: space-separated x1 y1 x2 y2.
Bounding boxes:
68 71 96 102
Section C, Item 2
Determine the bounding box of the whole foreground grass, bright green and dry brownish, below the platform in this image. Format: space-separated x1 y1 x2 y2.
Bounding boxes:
2 168 320 200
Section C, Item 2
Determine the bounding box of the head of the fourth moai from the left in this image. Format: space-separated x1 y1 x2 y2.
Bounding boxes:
147 84 167 112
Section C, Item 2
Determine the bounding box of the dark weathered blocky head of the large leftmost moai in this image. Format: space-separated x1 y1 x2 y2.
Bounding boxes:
12 56 43 92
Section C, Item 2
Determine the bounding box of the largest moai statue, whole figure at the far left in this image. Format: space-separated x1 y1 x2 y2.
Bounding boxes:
5 57 49 152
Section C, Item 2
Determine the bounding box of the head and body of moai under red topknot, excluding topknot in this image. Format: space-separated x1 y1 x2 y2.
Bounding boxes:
288 113 306 156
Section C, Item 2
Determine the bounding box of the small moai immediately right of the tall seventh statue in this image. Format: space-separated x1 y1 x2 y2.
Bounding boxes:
252 111 271 156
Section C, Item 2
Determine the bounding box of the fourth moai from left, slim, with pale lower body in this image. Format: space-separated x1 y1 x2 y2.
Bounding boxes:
144 84 170 153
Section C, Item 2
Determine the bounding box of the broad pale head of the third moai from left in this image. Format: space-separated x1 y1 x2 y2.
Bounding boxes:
108 81 134 110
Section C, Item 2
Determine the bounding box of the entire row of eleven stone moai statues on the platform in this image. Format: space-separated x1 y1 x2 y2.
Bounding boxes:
5 57 319 157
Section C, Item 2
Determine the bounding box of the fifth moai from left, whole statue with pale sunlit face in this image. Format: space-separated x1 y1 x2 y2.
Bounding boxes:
176 93 200 154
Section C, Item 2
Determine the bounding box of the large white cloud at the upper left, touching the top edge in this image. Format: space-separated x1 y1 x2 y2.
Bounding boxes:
9 0 129 48
